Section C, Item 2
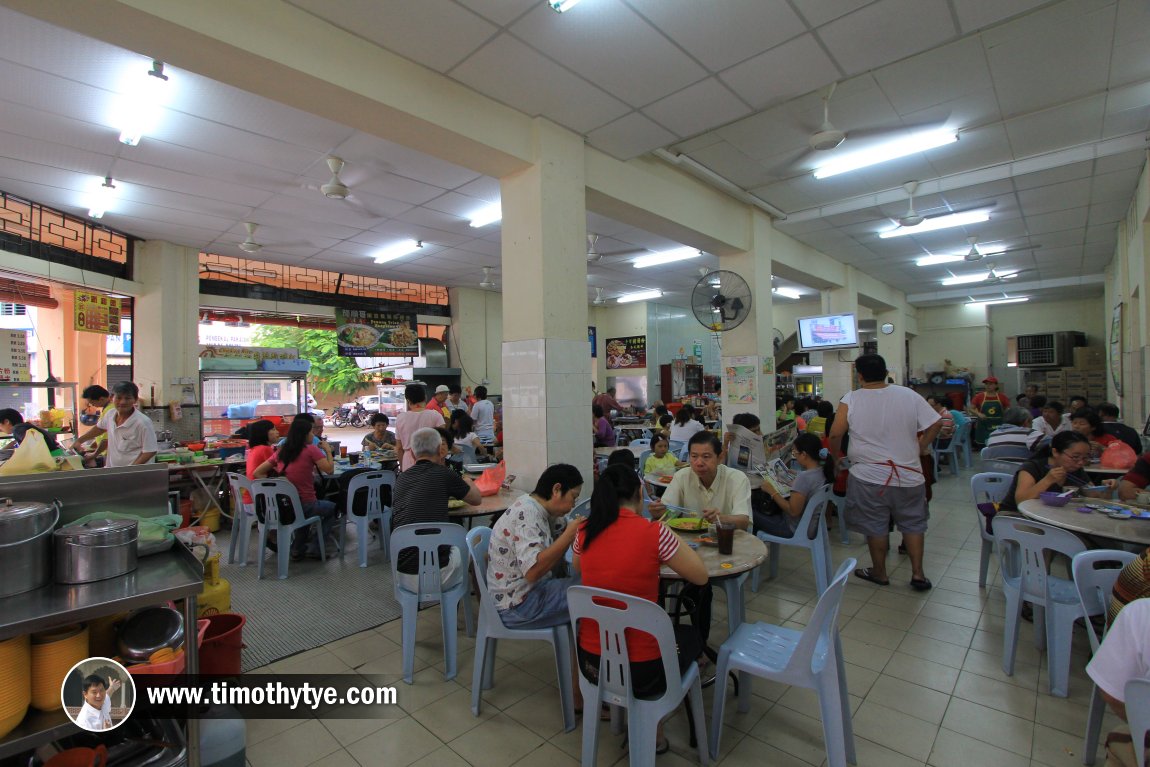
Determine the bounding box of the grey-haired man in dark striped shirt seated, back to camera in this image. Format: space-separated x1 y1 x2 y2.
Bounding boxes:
391 427 483 591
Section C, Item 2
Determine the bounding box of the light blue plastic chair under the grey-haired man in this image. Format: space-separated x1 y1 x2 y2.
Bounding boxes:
391 522 474 684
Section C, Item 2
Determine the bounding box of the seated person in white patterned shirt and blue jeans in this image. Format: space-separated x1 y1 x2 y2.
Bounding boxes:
488 463 583 629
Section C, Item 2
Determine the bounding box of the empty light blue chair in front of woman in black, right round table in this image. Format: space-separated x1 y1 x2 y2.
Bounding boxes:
992 514 1086 698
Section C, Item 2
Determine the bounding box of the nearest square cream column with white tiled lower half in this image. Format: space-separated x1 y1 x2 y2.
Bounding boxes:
500 120 592 494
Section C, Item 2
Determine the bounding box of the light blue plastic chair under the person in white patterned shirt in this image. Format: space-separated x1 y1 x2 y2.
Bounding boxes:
467 528 575 733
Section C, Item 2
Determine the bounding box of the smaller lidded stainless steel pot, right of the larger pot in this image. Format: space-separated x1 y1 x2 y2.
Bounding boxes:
54 520 139 583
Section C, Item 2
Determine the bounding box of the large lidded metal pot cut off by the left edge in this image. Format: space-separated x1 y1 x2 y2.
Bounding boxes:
0 498 60 598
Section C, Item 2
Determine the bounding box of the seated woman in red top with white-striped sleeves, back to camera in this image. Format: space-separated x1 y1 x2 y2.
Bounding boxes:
572 466 707 753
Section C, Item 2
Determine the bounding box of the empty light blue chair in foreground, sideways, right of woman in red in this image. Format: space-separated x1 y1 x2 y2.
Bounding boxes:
711 558 858 767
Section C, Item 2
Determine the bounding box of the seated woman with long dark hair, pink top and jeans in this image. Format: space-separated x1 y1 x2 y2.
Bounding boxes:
253 417 336 561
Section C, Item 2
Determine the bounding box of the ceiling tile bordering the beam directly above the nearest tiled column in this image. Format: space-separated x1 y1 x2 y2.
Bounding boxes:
451 34 628 133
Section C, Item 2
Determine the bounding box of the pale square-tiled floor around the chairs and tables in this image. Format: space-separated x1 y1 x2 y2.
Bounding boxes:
247 471 1114 767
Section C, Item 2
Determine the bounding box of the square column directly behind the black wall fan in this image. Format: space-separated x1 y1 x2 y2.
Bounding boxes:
719 210 775 432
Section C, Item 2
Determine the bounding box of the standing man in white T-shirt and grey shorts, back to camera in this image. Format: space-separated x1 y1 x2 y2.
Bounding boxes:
830 354 942 591
